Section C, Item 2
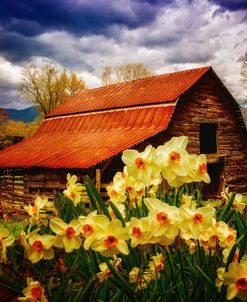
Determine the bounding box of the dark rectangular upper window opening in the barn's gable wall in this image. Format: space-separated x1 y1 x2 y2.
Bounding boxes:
200 123 217 154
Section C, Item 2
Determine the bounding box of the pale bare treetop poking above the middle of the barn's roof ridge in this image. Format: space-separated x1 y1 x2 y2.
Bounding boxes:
101 63 152 85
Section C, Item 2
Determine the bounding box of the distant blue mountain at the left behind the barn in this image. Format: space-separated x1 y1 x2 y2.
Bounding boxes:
4 106 39 123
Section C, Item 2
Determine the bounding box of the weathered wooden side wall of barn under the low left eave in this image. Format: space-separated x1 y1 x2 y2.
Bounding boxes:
0 168 93 214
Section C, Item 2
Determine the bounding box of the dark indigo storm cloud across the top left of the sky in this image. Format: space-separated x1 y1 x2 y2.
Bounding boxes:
0 0 172 36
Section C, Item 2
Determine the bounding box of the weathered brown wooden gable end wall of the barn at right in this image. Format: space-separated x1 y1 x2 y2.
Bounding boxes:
103 73 247 196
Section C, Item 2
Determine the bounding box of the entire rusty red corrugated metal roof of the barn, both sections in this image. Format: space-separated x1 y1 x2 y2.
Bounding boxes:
0 67 211 168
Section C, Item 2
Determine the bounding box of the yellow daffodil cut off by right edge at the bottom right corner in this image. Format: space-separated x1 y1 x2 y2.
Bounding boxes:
224 256 247 300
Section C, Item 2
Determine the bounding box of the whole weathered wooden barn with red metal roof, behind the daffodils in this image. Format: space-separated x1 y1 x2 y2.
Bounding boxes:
0 67 247 212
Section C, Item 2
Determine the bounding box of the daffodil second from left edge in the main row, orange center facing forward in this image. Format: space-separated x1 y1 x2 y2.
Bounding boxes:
26 234 55 263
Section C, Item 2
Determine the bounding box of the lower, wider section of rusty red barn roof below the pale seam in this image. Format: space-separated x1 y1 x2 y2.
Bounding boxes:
0 105 175 168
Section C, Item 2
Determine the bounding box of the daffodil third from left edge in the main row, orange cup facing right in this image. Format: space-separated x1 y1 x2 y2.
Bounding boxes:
50 218 82 253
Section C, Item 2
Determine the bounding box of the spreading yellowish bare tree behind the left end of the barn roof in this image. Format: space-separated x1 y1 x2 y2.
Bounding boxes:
18 63 86 116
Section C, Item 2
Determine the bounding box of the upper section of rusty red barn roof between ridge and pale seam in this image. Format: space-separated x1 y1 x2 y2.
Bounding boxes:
47 67 211 117
